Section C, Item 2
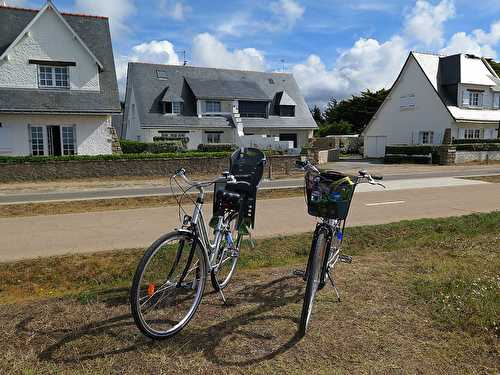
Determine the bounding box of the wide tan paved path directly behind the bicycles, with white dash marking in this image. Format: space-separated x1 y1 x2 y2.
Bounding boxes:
0 182 500 262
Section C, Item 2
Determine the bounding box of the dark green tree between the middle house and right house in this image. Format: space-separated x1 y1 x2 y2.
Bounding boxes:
324 89 389 133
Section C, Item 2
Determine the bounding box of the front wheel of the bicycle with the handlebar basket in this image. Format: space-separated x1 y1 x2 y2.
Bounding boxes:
299 230 326 336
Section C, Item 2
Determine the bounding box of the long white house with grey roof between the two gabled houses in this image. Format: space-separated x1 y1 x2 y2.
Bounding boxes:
121 63 317 150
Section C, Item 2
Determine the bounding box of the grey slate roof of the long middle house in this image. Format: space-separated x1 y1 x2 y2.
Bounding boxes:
125 63 316 129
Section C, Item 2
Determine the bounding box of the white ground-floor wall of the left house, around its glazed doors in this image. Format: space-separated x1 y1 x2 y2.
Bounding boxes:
0 114 112 156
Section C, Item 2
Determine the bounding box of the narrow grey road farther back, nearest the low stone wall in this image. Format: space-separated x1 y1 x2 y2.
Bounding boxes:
0 166 500 205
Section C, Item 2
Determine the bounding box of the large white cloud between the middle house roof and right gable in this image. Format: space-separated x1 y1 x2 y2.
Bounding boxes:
292 36 408 104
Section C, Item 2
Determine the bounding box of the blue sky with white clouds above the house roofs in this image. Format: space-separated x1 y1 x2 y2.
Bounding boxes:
7 0 500 104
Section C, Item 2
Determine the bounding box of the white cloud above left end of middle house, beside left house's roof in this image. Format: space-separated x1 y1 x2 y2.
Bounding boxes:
115 40 180 97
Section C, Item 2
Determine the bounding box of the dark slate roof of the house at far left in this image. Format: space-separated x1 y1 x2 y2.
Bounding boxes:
0 6 120 113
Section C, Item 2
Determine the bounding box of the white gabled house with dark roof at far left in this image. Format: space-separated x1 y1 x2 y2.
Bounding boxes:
0 1 120 156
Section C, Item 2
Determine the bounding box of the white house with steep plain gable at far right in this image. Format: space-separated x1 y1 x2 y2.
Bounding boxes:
362 52 500 157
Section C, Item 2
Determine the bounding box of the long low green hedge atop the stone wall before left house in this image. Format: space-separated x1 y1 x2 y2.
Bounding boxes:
0 151 231 164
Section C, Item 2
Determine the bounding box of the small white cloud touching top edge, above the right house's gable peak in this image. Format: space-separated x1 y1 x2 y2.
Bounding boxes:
405 0 455 47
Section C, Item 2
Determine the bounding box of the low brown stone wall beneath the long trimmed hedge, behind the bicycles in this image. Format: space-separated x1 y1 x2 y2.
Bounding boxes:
0 156 298 183
